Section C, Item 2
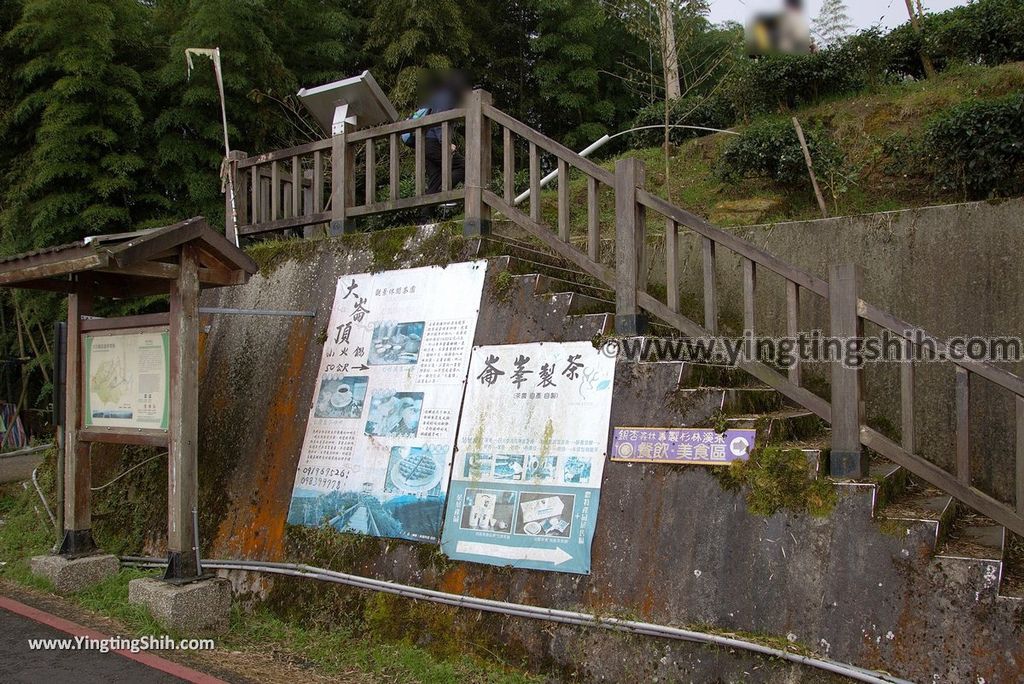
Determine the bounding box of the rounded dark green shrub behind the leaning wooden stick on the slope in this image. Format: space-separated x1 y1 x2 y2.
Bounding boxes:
718 120 843 188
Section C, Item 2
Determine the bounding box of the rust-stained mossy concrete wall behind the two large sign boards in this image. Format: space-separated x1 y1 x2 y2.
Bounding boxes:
193 223 1024 682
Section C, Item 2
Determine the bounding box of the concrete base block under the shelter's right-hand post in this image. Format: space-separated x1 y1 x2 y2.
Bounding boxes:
128 578 231 634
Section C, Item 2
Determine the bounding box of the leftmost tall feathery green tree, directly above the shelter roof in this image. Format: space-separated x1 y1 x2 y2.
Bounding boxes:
0 0 146 252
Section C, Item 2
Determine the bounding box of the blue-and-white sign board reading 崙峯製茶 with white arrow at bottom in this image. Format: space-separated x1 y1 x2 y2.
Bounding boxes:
441 342 615 574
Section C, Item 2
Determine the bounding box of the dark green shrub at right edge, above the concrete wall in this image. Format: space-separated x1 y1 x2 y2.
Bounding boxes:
921 93 1024 200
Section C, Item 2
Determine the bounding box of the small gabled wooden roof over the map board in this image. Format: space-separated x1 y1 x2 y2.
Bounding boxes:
0 216 258 298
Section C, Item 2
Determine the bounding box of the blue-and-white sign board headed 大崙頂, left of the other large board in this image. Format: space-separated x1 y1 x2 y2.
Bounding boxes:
288 261 486 542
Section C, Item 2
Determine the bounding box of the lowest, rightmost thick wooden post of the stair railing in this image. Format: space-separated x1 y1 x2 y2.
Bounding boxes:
828 264 867 478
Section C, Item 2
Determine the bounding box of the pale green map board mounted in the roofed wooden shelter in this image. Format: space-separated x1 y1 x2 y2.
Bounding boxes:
82 329 171 430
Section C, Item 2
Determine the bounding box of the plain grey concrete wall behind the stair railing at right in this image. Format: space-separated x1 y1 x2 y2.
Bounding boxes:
638 199 1024 501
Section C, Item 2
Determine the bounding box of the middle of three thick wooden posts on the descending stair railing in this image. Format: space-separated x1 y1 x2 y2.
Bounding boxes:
615 157 646 335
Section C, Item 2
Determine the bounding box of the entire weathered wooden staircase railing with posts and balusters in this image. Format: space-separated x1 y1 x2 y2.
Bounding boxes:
227 90 1024 535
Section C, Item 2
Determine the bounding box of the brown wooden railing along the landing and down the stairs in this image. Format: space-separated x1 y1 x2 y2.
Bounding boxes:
224 91 1024 535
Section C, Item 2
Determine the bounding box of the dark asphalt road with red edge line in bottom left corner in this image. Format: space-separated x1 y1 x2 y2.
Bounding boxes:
0 605 209 684
